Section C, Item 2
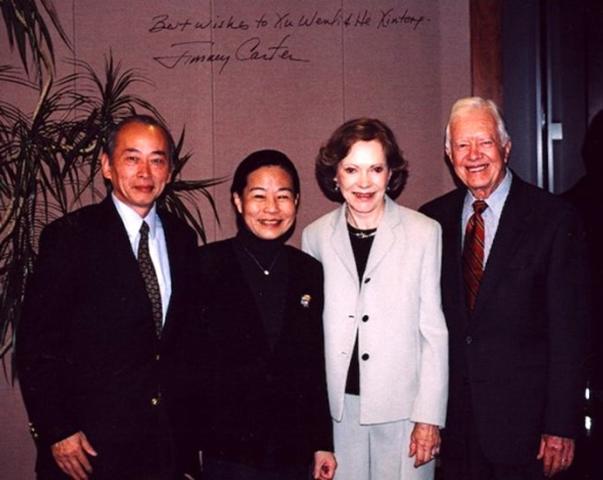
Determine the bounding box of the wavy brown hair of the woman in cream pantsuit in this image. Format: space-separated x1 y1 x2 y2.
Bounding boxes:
315 117 408 203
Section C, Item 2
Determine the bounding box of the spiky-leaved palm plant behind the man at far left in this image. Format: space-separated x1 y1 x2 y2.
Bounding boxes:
0 0 222 359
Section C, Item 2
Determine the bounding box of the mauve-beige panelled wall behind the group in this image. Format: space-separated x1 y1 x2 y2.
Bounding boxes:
0 0 470 479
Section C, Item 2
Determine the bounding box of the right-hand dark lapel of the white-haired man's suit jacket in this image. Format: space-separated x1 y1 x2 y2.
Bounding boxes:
473 175 532 317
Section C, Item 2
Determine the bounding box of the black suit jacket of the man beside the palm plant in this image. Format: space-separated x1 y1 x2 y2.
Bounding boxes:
16 197 196 478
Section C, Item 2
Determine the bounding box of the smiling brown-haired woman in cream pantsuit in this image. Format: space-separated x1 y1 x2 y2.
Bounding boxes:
302 118 448 480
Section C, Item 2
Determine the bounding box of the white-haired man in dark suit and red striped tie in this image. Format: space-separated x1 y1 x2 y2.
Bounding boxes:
422 97 589 480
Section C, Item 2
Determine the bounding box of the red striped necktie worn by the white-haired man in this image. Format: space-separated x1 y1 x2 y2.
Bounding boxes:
463 200 488 311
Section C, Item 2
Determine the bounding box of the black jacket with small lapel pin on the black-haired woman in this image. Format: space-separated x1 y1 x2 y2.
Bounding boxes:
199 239 333 466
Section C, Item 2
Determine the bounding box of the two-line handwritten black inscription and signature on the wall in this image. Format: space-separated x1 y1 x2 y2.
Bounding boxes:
148 7 430 73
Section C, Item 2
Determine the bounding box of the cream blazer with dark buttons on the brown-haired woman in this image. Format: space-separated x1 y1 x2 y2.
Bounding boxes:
302 197 448 426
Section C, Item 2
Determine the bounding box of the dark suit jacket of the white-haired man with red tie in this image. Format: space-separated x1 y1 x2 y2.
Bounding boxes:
421 175 589 463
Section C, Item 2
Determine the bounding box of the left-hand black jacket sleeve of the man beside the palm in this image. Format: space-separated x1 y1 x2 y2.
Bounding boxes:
16 221 80 445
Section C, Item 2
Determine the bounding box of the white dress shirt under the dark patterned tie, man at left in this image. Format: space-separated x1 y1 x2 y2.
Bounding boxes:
111 194 172 324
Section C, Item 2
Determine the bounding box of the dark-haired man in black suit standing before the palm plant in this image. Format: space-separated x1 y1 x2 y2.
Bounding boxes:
17 116 196 480
